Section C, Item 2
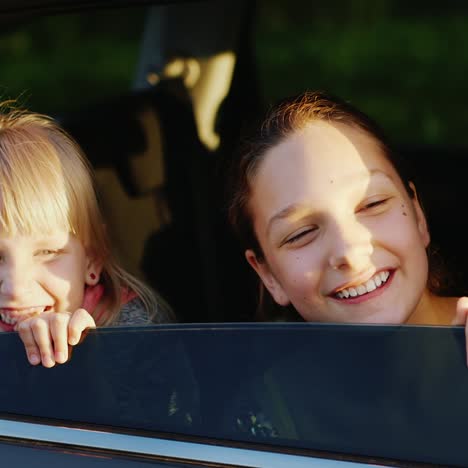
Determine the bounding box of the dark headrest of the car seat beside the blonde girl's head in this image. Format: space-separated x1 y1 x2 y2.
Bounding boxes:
58 93 165 196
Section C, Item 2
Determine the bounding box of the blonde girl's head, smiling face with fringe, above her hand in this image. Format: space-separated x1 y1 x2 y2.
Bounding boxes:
0 109 111 331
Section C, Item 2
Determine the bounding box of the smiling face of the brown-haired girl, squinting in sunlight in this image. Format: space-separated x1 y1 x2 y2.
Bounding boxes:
246 122 429 323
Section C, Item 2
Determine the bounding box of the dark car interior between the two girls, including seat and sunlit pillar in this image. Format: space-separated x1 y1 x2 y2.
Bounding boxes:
59 2 260 322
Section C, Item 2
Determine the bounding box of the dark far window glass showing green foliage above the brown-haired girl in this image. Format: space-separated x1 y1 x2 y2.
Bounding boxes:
256 0 468 146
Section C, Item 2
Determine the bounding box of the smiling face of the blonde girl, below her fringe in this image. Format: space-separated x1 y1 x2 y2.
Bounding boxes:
0 231 99 331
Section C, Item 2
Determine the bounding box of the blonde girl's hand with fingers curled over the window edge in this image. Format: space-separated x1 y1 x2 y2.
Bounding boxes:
16 309 96 367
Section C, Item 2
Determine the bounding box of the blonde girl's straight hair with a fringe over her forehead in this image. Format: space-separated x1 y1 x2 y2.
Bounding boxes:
0 101 158 325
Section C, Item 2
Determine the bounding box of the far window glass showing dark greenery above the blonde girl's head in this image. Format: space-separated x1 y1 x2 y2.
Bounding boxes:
0 8 146 113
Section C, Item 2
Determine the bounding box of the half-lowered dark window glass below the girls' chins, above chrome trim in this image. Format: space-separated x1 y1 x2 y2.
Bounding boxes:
0 324 468 465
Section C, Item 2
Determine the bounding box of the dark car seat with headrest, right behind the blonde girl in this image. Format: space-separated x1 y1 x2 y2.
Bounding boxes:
60 80 216 321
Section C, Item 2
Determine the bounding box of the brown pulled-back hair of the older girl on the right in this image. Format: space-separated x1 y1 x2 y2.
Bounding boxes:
228 91 442 318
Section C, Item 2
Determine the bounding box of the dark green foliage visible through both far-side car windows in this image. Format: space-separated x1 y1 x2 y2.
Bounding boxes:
0 0 468 146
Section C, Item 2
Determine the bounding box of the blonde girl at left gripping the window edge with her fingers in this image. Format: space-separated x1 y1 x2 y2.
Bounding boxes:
0 103 171 367
